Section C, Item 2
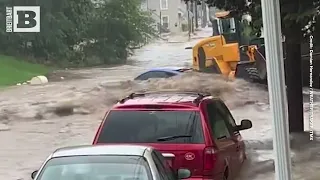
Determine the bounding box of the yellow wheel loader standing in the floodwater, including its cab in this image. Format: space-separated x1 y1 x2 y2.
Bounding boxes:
192 11 267 83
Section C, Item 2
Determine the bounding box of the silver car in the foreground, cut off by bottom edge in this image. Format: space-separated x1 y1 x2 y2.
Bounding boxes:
31 145 191 180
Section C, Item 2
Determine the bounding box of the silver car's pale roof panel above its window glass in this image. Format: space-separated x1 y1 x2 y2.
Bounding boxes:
51 145 152 158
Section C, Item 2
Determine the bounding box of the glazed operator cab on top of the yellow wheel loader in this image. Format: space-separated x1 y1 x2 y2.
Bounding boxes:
215 11 243 45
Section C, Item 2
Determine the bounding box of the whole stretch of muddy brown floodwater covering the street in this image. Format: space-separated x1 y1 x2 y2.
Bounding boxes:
0 30 320 180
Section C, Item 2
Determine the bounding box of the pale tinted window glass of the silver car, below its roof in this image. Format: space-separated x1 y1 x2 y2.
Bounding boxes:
37 156 152 180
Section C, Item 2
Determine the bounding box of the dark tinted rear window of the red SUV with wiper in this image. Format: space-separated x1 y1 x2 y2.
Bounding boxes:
97 110 204 144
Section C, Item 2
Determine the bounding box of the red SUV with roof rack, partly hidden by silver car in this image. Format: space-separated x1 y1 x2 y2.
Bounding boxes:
93 92 252 180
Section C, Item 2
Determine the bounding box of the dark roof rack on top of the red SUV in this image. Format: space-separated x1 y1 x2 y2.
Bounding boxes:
119 91 211 104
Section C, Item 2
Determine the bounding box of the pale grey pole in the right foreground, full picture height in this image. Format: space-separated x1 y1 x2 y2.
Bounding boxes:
261 0 292 180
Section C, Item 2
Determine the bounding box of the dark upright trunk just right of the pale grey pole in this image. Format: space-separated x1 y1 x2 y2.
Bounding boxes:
285 22 304 132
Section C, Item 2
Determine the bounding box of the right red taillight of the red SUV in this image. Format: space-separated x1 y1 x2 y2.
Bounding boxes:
203 147 216 176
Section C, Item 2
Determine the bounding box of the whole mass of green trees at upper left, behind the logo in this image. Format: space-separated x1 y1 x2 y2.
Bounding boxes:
0 0 155 66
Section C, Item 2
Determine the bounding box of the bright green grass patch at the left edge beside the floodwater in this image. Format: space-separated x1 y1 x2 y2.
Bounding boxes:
0 55 50 87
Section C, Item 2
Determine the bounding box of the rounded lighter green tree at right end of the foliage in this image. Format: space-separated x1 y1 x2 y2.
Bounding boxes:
84 0 154 63
